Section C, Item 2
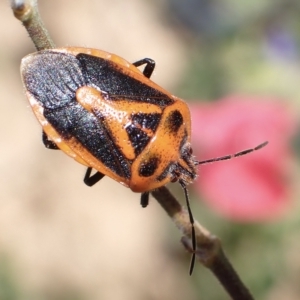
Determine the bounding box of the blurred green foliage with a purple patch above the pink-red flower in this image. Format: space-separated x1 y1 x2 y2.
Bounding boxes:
170 0 300 101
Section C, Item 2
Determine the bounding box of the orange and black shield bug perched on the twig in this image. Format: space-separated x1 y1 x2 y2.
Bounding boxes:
21 47 266 274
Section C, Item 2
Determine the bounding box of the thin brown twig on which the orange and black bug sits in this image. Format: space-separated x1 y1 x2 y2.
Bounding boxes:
11 0 253 300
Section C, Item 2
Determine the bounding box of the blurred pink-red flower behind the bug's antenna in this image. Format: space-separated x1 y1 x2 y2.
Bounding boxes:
190 96 296 222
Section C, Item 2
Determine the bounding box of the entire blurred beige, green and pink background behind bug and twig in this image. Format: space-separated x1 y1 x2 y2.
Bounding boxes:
0 0 300 300
